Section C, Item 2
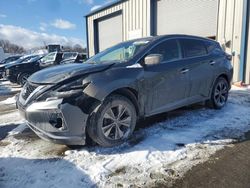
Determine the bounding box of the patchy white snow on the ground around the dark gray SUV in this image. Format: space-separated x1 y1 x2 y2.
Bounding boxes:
0 81 250 188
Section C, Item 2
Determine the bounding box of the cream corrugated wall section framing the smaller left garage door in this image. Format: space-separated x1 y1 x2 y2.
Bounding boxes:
87 0 151 56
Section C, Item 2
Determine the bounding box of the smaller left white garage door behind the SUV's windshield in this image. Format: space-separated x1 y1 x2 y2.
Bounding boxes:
98 14 122 52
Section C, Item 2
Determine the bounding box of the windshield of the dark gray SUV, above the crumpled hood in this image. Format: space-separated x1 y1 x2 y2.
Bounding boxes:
85 40 150 64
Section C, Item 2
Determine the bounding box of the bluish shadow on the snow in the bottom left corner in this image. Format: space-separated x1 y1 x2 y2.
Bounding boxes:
0 157 96 188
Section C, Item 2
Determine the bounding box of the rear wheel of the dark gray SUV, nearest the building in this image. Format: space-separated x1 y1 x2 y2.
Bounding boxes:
207 77 229 109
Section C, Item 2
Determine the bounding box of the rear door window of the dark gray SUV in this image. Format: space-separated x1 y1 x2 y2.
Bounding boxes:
181 39 207 58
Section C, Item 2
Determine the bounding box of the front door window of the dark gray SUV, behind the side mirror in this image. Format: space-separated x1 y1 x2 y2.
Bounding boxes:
150 40 181 62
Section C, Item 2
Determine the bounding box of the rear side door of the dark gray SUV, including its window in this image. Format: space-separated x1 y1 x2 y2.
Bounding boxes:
180 39 214 101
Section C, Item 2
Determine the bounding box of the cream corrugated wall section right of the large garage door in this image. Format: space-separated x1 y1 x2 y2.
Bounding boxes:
217 0 244 82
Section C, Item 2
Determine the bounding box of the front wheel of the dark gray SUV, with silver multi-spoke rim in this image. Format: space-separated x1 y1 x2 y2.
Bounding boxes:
87 95 137 147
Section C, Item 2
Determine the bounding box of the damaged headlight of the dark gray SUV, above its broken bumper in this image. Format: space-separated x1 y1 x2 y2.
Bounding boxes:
38 79 90 101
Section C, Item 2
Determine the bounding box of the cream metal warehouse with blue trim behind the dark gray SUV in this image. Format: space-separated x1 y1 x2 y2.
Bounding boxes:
86 0 250 83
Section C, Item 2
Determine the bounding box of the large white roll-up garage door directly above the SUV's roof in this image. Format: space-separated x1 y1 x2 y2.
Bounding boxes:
156 0 219 37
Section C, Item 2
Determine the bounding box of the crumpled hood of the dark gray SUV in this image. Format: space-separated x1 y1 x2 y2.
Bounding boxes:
28 64 112 84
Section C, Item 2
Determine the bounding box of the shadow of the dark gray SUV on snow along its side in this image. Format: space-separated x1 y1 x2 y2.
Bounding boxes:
86 87 250 155
